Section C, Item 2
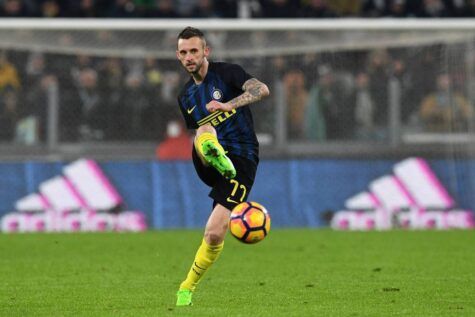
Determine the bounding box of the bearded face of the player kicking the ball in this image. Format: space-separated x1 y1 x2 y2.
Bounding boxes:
176 37 209 74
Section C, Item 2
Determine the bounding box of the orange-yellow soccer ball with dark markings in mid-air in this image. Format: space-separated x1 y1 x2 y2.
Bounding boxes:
229 201 270 243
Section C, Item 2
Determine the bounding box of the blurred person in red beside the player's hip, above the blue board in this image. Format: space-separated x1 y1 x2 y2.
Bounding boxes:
156 120 193 160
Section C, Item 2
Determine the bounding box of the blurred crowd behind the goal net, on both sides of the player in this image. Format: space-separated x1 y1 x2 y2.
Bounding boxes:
0 45 475 144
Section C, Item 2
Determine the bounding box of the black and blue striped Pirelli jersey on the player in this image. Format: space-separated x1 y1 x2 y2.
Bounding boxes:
178 62 259 163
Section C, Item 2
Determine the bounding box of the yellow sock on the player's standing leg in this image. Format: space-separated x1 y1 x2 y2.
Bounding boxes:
180 239 224 291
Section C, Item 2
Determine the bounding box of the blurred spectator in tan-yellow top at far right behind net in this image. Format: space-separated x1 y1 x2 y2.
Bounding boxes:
419 73 473 132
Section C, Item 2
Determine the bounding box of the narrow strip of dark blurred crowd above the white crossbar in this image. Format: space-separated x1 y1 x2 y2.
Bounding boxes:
0 0 475 18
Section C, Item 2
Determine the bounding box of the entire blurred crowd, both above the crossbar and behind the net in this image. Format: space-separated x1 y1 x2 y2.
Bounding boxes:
0 0 475 146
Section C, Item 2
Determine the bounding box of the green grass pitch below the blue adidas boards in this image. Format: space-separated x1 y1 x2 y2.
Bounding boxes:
0 229 475 317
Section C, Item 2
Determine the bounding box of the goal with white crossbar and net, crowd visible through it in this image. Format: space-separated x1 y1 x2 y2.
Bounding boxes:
0 19 475 157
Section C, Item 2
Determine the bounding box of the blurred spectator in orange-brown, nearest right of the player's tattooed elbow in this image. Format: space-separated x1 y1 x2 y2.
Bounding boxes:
283 69 308 139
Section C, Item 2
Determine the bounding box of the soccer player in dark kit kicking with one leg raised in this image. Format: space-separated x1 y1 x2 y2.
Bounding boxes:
176 27 269 306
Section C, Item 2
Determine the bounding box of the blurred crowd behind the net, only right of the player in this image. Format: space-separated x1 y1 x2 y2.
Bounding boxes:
273 45 475 142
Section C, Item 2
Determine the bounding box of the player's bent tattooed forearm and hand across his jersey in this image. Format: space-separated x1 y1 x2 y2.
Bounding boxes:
206 78 270 112
